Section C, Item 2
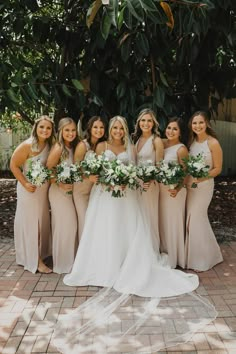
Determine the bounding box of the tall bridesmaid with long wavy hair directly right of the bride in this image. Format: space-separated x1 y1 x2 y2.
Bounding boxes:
133 108 164 252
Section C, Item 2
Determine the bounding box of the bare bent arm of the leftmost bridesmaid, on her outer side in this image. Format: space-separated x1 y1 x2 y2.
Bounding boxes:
10 141 36 193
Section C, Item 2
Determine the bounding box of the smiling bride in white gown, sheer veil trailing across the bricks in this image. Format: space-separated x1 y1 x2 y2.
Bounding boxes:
54 116 215 353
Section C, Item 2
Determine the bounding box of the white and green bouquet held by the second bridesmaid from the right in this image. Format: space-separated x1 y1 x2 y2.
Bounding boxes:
156 161 186 189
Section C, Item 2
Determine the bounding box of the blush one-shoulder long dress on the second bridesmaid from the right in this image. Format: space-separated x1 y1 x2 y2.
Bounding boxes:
159 144 186 268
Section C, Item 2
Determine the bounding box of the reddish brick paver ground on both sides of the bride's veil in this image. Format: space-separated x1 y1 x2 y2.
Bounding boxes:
0 242 236 354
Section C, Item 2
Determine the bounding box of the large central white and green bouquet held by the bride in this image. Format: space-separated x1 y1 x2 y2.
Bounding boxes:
100 159 139 198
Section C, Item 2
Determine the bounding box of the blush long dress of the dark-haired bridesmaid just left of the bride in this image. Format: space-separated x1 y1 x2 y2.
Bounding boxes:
73 140 94 241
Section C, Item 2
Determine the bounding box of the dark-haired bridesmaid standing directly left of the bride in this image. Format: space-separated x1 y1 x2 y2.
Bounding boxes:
73 116 105 241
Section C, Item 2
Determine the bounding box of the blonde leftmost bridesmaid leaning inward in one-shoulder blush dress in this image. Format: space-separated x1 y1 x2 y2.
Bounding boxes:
10 115 54 273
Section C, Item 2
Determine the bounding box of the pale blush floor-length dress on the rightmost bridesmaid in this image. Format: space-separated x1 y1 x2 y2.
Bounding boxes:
185 140 223 271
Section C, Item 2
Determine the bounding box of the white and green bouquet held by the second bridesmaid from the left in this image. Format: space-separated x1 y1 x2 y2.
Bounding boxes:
56 161 82 194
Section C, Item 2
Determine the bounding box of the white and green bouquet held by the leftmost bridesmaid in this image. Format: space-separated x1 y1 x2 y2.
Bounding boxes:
26 159 51 187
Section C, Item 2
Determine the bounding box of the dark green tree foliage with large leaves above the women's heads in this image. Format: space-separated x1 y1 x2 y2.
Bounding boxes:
0 0 236 129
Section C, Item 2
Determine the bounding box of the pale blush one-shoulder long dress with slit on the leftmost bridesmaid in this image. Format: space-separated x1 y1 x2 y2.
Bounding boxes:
14 145 51 273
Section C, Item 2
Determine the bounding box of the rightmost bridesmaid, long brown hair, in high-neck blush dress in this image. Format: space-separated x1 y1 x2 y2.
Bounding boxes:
186 111 223 271
